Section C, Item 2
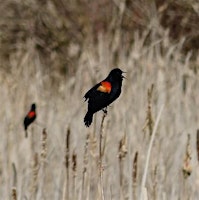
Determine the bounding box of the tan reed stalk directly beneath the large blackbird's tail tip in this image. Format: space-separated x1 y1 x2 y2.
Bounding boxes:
81 134 90 199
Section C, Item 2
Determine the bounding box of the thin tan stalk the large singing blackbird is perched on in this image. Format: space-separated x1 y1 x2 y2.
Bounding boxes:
99 112 107 200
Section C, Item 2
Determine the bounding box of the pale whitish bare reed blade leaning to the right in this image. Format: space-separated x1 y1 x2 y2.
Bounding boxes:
140 105 164 200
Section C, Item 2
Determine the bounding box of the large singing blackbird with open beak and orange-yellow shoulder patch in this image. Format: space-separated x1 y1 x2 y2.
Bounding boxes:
84 68 124 127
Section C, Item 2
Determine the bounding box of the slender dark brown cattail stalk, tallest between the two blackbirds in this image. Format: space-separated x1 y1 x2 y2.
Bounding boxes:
63 128 70 200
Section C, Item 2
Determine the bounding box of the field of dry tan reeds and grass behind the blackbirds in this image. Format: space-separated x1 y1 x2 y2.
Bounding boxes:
0 1 199 200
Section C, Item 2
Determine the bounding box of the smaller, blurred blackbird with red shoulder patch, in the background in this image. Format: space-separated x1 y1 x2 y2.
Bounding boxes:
24 103 36 137
